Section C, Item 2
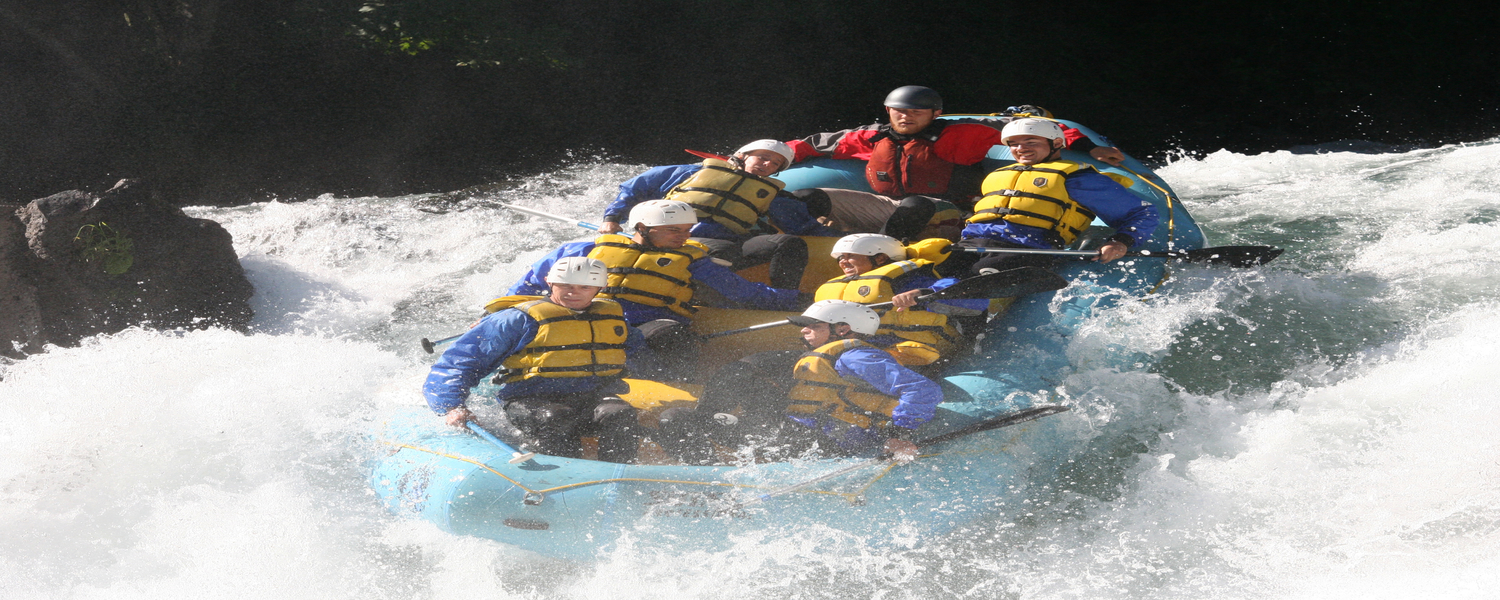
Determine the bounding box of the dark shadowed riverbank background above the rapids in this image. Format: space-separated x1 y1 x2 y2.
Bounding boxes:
0 0 1500 204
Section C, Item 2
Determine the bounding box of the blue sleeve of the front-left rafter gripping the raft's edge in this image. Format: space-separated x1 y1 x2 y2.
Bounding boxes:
422 309 537 414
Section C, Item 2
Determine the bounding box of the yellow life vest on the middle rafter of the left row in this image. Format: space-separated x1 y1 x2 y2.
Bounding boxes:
588 234 708 317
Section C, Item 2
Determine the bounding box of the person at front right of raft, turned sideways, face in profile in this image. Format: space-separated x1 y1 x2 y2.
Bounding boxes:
662 300 944 464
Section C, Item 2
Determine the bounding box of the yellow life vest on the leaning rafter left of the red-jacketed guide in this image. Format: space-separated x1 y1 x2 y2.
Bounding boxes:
665 159 786 236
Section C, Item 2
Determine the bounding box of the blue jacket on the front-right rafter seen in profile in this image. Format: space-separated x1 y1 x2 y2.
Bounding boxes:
789 347 942 447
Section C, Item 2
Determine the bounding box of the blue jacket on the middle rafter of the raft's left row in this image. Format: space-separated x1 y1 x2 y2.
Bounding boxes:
506 242 803 326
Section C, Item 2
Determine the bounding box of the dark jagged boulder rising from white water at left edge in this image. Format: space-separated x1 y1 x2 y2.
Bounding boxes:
0 180 254 356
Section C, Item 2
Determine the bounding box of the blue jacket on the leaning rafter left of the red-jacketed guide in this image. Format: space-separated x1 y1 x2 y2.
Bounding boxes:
605 165 843 242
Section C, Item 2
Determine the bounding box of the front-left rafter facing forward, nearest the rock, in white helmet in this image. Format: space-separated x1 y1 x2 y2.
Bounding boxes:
422 257 644 462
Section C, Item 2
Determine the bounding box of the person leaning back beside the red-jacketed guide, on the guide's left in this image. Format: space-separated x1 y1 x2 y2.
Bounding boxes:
599 140 839 288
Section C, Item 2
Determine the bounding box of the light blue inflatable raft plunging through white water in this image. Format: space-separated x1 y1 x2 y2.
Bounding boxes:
371 117 1205 560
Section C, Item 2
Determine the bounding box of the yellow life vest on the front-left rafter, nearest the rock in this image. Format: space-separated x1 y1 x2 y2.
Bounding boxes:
486 296 629 383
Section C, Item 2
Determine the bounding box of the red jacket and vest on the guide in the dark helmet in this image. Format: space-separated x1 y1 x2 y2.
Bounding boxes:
786 117 1098 198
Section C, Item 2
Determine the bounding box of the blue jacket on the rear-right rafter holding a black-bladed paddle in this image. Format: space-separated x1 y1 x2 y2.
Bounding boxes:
963 173 1157 249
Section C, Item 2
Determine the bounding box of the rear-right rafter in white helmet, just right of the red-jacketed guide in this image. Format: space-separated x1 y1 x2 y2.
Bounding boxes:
938 119 1158 276
